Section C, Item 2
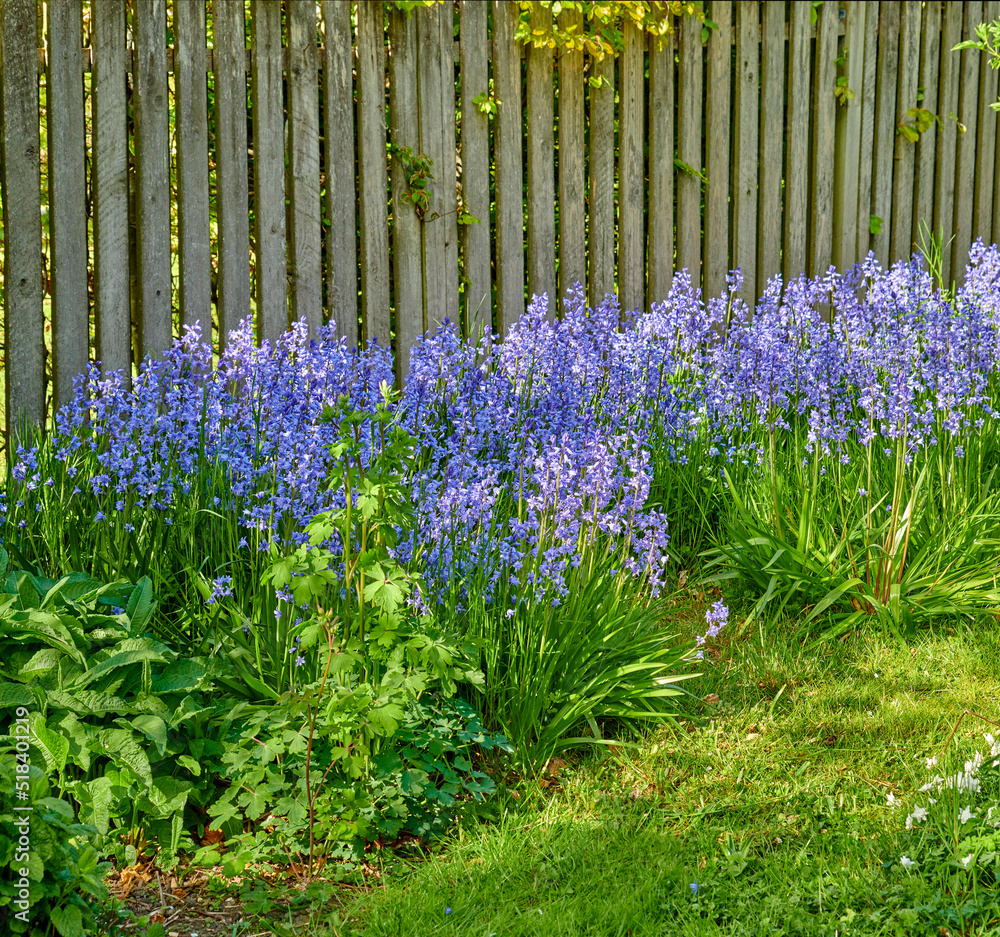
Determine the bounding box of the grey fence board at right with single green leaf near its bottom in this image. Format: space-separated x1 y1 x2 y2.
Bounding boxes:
871 0 900 267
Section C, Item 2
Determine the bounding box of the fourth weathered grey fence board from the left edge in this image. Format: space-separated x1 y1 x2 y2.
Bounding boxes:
133 0 171 357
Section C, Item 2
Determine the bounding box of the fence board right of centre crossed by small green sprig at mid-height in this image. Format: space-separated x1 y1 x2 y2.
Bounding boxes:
677 16 704 287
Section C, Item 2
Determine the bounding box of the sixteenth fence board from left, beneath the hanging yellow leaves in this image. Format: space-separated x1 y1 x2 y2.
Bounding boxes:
557 11 584 310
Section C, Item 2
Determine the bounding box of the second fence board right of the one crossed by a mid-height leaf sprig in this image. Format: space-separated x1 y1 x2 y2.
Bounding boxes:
733 0 760 309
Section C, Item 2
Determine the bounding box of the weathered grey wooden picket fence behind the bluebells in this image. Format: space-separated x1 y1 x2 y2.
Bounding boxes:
0 0 1000 436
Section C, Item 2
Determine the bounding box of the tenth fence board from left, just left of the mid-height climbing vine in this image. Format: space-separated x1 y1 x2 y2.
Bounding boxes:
358 3 392 346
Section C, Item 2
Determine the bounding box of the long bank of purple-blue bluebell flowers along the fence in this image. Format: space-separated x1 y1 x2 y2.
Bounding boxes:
3 242 1000 624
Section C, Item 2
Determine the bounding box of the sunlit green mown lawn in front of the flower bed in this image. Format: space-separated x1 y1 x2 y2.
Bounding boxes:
300 619 1000 937
